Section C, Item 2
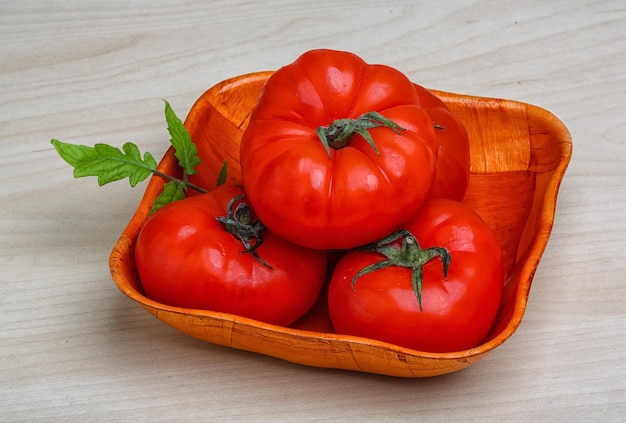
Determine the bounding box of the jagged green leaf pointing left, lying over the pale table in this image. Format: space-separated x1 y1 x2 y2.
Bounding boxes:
50 139 157 187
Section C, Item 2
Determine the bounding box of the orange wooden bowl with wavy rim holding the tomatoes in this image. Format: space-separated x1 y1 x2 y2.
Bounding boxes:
110 72 572 378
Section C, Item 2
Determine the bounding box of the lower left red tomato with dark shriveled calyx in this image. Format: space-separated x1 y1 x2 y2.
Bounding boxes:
135 184 326 326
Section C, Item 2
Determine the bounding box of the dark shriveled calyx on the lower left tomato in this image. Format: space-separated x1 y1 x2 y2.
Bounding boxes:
216 194 272 269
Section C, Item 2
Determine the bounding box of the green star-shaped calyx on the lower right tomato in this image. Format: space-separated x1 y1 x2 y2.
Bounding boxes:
351 229 452 310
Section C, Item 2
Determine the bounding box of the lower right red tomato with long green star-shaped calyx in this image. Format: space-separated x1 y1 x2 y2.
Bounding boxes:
328 199 504 352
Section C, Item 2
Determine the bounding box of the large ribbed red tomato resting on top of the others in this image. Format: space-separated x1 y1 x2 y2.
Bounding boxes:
240 50 436 249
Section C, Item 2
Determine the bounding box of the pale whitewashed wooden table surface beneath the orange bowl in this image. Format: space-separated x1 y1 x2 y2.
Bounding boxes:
0 0 626 423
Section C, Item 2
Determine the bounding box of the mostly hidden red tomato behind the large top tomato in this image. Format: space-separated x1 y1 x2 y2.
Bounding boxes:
415 84 470 201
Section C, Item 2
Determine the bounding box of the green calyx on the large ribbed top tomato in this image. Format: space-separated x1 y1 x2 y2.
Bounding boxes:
317 111 405 158
